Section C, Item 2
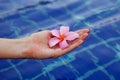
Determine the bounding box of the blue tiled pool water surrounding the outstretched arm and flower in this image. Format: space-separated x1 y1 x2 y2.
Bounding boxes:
0 0 120 80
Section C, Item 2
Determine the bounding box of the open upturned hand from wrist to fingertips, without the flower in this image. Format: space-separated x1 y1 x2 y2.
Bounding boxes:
24 29 90 59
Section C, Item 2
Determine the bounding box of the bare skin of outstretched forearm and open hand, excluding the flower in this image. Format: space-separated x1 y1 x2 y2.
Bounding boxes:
0 29 90 59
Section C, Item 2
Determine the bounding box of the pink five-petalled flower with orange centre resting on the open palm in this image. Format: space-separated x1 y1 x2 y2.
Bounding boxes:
49 26 79 49
